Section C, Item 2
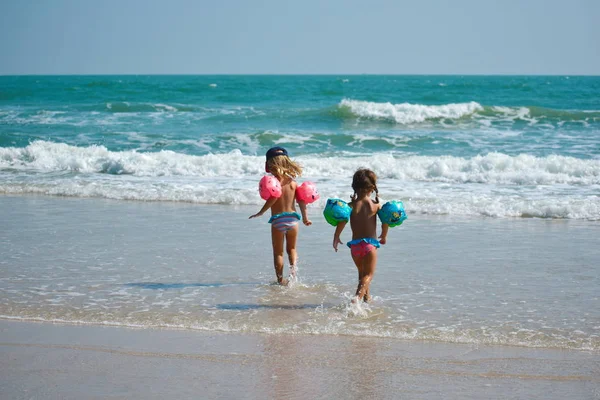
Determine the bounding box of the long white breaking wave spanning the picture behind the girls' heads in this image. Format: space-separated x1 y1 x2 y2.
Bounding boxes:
0 140 600 185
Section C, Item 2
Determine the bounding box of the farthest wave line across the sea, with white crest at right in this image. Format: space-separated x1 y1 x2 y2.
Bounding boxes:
0 99 600 130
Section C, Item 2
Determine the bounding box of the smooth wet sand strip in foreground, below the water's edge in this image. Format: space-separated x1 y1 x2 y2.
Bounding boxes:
0 320 600 399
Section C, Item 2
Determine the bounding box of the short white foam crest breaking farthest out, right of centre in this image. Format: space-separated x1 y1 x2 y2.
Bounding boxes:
339 99 483 124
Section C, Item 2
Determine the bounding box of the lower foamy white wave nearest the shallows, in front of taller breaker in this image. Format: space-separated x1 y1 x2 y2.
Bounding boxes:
0 180 600 221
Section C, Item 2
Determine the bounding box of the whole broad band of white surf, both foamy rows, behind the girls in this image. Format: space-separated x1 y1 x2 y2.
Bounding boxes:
0 141 600 220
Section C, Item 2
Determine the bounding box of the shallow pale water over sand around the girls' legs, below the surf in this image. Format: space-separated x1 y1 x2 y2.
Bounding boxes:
0 196 600 351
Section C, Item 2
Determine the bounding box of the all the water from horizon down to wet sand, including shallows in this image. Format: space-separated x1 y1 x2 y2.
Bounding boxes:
0 75 600 354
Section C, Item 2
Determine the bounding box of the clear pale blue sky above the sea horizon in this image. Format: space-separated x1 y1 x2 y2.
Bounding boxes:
0 0 600 75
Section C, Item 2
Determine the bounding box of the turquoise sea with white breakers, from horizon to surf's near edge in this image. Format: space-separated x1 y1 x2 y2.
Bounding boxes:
0 75 600 221
